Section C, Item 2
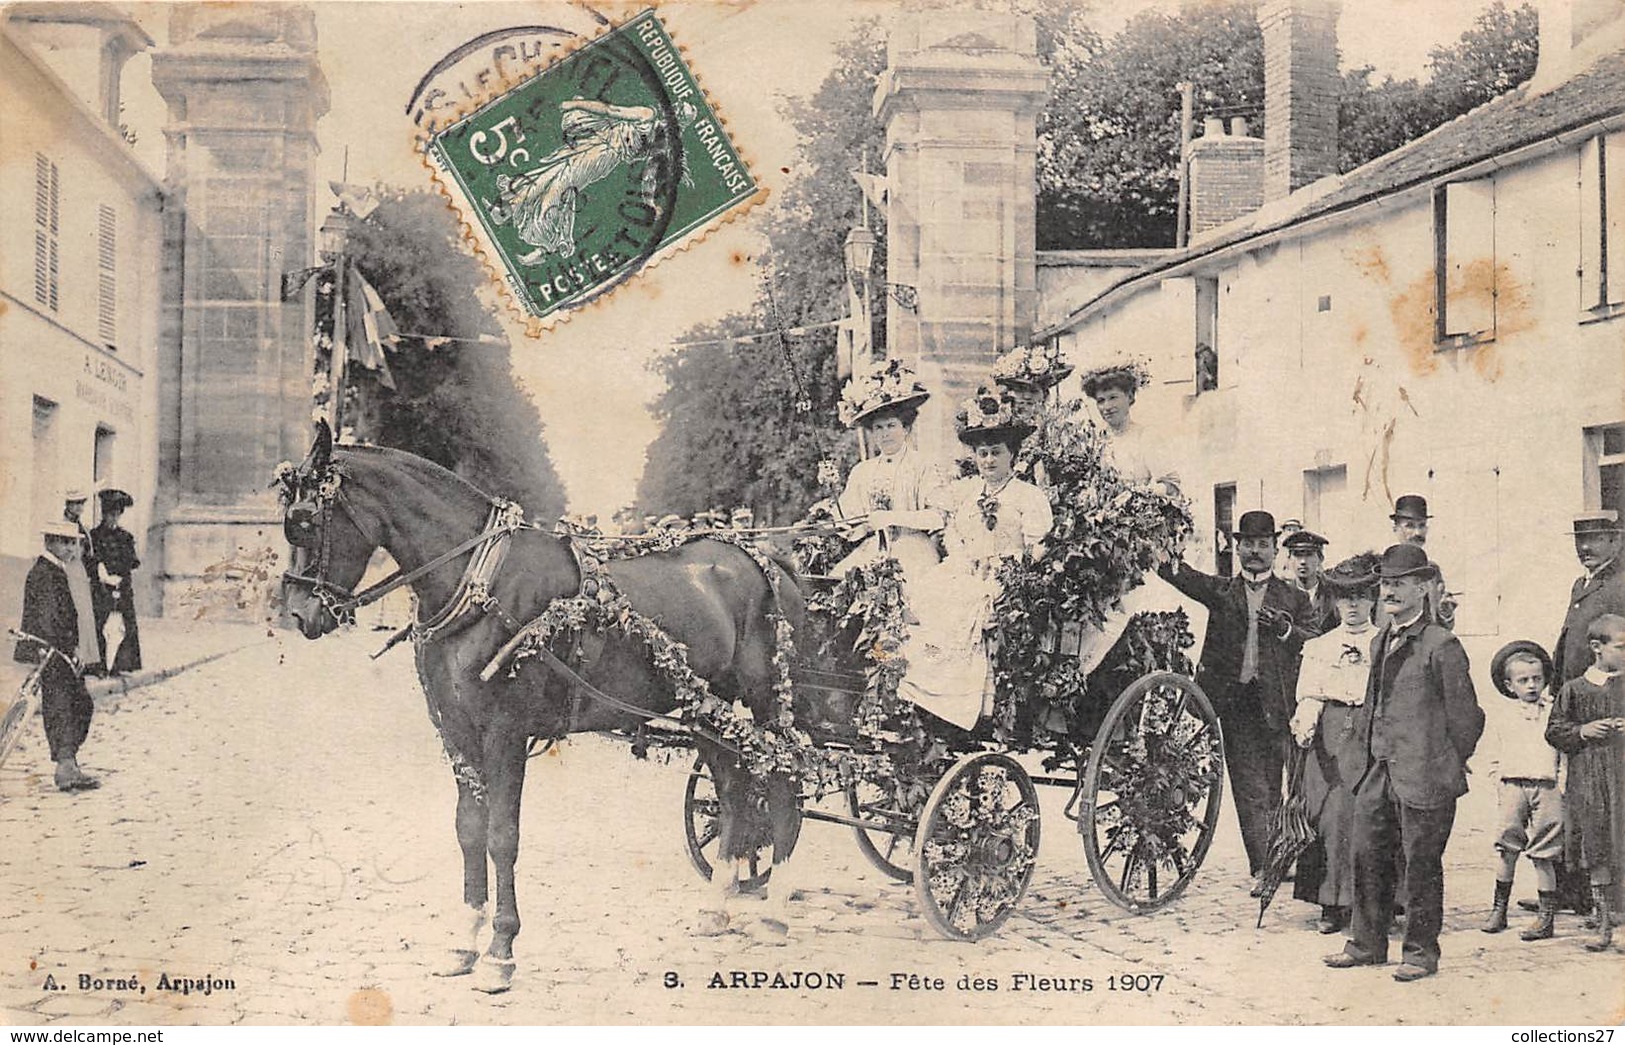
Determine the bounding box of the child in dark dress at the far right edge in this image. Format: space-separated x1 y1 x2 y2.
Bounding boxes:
1545 613 1625 951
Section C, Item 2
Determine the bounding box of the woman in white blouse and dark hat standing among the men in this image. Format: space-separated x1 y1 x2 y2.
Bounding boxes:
1292 553 1378 933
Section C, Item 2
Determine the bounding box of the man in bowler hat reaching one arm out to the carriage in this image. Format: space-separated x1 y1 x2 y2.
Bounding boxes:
1164 512 1315 876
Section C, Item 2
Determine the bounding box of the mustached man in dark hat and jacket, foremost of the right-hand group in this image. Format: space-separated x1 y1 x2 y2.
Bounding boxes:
1326 544 1484 983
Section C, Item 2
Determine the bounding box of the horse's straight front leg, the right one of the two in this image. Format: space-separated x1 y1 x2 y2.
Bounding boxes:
473 713 527 995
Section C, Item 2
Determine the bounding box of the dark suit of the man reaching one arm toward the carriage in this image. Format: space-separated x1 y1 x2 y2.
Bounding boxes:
1164 562 1316 874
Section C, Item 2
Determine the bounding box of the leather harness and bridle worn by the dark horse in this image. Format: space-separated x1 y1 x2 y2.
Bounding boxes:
283 466 736 751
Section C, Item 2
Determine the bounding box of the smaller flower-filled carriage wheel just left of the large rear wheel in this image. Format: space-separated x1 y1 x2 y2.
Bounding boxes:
915 751 1038 939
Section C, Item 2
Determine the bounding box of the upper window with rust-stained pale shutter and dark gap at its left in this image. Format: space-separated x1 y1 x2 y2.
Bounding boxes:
1433 177 1495 346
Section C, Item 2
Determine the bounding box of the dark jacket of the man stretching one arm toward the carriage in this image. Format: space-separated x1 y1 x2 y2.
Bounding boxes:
1162 562 1318 730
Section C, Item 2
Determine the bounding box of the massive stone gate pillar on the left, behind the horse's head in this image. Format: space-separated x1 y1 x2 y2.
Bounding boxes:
153 3 328 614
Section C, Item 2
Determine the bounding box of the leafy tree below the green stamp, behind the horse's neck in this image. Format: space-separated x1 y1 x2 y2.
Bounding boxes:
339 189 564 520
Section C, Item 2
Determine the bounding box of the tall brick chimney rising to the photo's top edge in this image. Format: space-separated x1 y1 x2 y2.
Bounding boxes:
1258 0 1341 202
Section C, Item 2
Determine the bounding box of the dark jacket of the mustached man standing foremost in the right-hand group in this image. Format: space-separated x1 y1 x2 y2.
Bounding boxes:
1355 613 1484 809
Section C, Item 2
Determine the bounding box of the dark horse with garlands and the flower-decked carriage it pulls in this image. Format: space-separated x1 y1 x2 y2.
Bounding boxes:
275 426 1222 991
